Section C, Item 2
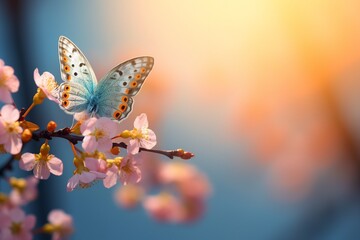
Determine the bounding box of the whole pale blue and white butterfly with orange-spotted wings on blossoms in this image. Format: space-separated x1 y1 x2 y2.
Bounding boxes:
58 36 154 121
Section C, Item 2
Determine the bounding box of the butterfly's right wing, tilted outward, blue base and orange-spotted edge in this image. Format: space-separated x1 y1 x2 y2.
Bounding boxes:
95 57 154 121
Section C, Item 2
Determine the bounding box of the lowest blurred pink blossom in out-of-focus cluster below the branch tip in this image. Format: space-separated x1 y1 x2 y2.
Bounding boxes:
143 193 184 222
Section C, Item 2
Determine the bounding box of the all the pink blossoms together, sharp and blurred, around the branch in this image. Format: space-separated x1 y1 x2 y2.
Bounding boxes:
0 60 210 239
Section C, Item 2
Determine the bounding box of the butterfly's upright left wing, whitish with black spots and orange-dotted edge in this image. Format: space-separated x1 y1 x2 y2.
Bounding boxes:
58 36 97 114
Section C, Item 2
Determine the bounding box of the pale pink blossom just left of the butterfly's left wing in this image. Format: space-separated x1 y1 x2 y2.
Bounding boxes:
34 68 60 104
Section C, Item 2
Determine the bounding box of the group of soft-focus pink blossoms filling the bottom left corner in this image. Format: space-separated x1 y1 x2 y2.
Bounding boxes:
0 177 73 240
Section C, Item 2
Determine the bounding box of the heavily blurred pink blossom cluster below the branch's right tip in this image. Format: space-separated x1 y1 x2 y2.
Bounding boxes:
115 159 211 223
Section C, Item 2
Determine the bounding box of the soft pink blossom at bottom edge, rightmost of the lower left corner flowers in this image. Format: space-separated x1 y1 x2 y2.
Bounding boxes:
48 209 74 240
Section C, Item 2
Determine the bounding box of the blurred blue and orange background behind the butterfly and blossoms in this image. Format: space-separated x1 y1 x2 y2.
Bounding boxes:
0 0 360 240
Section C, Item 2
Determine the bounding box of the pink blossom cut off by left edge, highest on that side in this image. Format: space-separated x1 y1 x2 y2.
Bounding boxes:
0 59 20 103
